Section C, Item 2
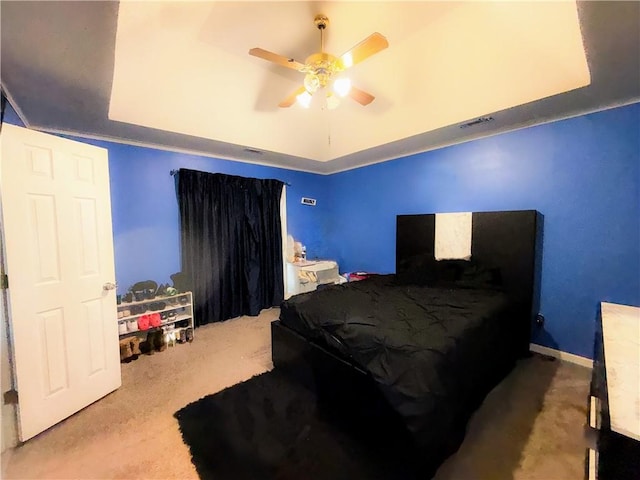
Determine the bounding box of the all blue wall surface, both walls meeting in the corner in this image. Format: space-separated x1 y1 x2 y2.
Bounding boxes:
5 98 640 357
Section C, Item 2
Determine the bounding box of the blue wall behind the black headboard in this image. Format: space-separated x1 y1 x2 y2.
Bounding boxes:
326 104 640 357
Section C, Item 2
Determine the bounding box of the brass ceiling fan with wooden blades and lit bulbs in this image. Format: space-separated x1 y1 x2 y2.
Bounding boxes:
249 14 389 109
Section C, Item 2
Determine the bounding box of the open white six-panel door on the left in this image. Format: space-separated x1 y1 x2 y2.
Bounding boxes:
0 124 121 441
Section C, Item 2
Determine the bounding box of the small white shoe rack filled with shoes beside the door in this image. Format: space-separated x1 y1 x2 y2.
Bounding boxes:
117 292 194 362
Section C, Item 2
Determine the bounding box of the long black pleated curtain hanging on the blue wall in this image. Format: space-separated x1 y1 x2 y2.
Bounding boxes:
176 168 284 326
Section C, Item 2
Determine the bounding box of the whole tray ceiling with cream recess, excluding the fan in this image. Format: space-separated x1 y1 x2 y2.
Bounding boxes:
0 1 640 173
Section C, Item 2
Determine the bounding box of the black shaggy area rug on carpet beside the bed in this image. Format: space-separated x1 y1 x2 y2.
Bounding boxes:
175 370 414 480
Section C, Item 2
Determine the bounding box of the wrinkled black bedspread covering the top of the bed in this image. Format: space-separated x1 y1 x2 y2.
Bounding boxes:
280 275 517 450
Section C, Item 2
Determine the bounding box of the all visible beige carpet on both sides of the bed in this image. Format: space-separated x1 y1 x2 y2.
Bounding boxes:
2 309 590 480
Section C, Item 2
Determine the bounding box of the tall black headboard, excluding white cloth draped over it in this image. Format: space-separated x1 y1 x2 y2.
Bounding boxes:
396 210 543 354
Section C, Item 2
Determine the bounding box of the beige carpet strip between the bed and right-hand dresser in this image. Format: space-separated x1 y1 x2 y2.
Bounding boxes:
435 354 591 480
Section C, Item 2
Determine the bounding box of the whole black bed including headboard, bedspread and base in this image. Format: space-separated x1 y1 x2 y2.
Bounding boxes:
272 210 542 476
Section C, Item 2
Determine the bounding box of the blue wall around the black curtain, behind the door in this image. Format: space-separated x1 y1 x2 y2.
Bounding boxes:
5 103 327 293
